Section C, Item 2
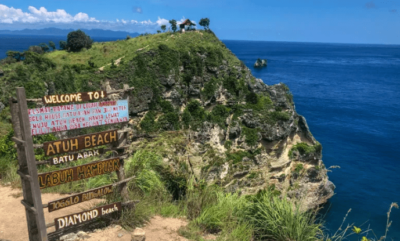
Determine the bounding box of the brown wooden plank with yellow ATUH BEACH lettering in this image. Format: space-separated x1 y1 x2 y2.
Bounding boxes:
43 129 118 156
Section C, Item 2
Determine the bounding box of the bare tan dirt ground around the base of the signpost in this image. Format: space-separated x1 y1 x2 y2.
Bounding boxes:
0 185 187 241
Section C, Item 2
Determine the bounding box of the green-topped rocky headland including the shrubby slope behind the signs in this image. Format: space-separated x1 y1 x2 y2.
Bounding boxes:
0 31 335 208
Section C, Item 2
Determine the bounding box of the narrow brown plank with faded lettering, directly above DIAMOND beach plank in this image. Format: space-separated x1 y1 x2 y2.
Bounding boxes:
48 185 113 212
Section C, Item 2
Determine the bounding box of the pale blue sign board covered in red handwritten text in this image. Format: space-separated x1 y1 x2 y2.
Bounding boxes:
28 100 129 136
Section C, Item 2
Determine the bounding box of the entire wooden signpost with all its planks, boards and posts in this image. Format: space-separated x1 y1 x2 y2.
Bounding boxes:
10 85 137 241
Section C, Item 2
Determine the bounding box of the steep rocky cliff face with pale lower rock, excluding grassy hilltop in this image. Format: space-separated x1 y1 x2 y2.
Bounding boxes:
101 32 335 209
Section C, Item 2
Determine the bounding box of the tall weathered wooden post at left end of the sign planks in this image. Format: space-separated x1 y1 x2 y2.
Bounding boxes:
10 87 48 241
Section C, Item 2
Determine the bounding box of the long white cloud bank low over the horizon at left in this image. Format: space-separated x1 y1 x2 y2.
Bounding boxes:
0 4 169 32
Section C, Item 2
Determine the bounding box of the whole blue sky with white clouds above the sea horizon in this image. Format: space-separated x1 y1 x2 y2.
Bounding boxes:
0 0 400 44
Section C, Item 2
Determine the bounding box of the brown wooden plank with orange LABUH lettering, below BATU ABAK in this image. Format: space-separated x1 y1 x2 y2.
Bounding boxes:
38 157 121 189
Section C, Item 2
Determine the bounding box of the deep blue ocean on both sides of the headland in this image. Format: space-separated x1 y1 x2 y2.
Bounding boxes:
0 35 400 240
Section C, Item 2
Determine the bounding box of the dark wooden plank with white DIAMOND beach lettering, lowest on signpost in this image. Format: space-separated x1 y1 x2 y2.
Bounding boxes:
54 202 122 230
